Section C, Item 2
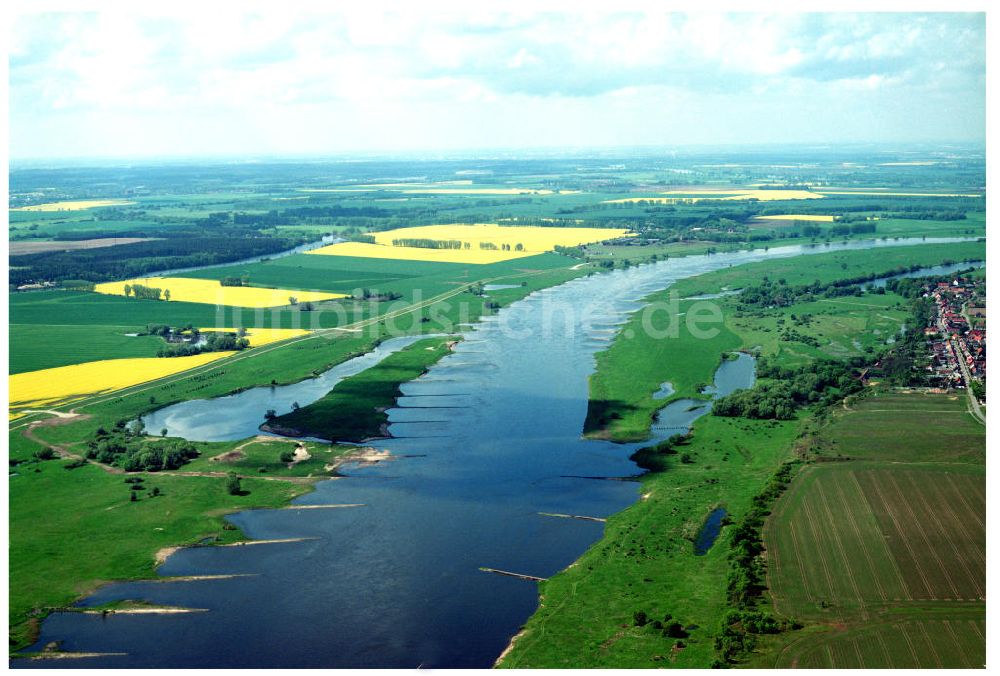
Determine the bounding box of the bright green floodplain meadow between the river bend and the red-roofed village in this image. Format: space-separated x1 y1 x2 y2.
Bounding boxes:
585 242 986 441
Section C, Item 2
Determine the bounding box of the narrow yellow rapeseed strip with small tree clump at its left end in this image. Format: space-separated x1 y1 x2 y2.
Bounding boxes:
94 277 345 308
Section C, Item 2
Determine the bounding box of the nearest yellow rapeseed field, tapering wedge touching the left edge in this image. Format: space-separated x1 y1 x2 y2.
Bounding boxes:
8 352 235 409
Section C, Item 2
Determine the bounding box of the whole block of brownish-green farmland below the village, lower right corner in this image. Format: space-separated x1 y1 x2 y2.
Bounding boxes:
754 392 986 668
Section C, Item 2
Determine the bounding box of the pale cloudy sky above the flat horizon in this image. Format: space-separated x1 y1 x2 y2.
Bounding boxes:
9 10 986 159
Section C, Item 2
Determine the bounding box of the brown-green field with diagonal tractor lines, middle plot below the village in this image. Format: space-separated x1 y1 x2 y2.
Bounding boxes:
768 463 986 618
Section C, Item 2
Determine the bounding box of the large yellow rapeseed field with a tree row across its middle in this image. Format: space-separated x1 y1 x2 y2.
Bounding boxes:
307 223 629 265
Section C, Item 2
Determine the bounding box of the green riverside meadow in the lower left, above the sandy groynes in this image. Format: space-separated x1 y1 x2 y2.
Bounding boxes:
9 428 308 650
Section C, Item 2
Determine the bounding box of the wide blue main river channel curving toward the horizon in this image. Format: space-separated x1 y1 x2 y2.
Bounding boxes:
15 235 976 668
